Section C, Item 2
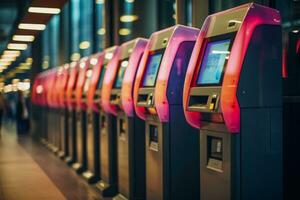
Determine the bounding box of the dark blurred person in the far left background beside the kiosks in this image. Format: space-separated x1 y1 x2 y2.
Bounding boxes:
16 91 29 134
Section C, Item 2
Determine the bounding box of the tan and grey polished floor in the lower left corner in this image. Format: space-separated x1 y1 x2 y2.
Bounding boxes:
0 122 101 200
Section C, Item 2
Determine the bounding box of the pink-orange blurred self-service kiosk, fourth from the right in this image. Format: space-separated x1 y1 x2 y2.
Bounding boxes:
88 46 118 196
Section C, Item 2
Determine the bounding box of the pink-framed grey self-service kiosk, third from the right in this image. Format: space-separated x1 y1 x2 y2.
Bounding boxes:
102 38 147 200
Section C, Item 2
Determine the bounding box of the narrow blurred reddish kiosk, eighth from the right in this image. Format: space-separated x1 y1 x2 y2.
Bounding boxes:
58 64 70 158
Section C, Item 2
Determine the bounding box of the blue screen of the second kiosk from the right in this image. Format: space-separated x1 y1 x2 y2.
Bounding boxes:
143 51 163 87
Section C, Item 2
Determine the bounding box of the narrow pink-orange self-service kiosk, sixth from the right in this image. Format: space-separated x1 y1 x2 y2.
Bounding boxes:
72 57 91 173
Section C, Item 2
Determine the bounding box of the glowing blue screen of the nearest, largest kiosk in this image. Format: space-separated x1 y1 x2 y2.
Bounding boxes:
197 39 230 85
